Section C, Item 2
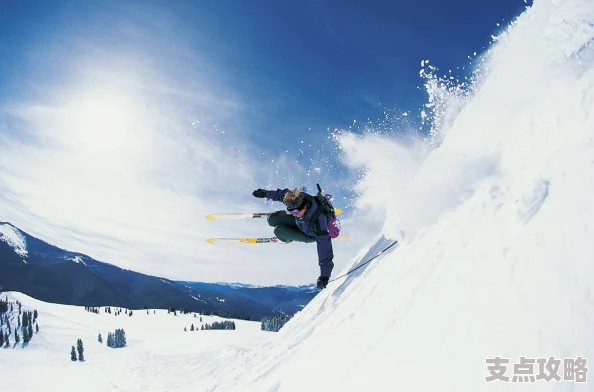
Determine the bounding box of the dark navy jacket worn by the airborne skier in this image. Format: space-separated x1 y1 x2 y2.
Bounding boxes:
266 188 334 278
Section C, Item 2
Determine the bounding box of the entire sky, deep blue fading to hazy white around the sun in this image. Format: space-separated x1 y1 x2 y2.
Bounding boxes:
0 0 527 284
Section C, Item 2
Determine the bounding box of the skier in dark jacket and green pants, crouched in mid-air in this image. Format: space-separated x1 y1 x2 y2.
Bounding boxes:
252 188 334 289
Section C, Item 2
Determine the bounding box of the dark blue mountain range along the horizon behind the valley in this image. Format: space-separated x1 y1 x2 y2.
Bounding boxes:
0 222 317 320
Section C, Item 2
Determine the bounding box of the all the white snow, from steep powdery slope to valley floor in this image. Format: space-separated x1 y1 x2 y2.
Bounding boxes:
0 0 594 392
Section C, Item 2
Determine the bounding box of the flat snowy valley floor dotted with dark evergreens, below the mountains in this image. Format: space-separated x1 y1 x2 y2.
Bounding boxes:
0 292 272 392
